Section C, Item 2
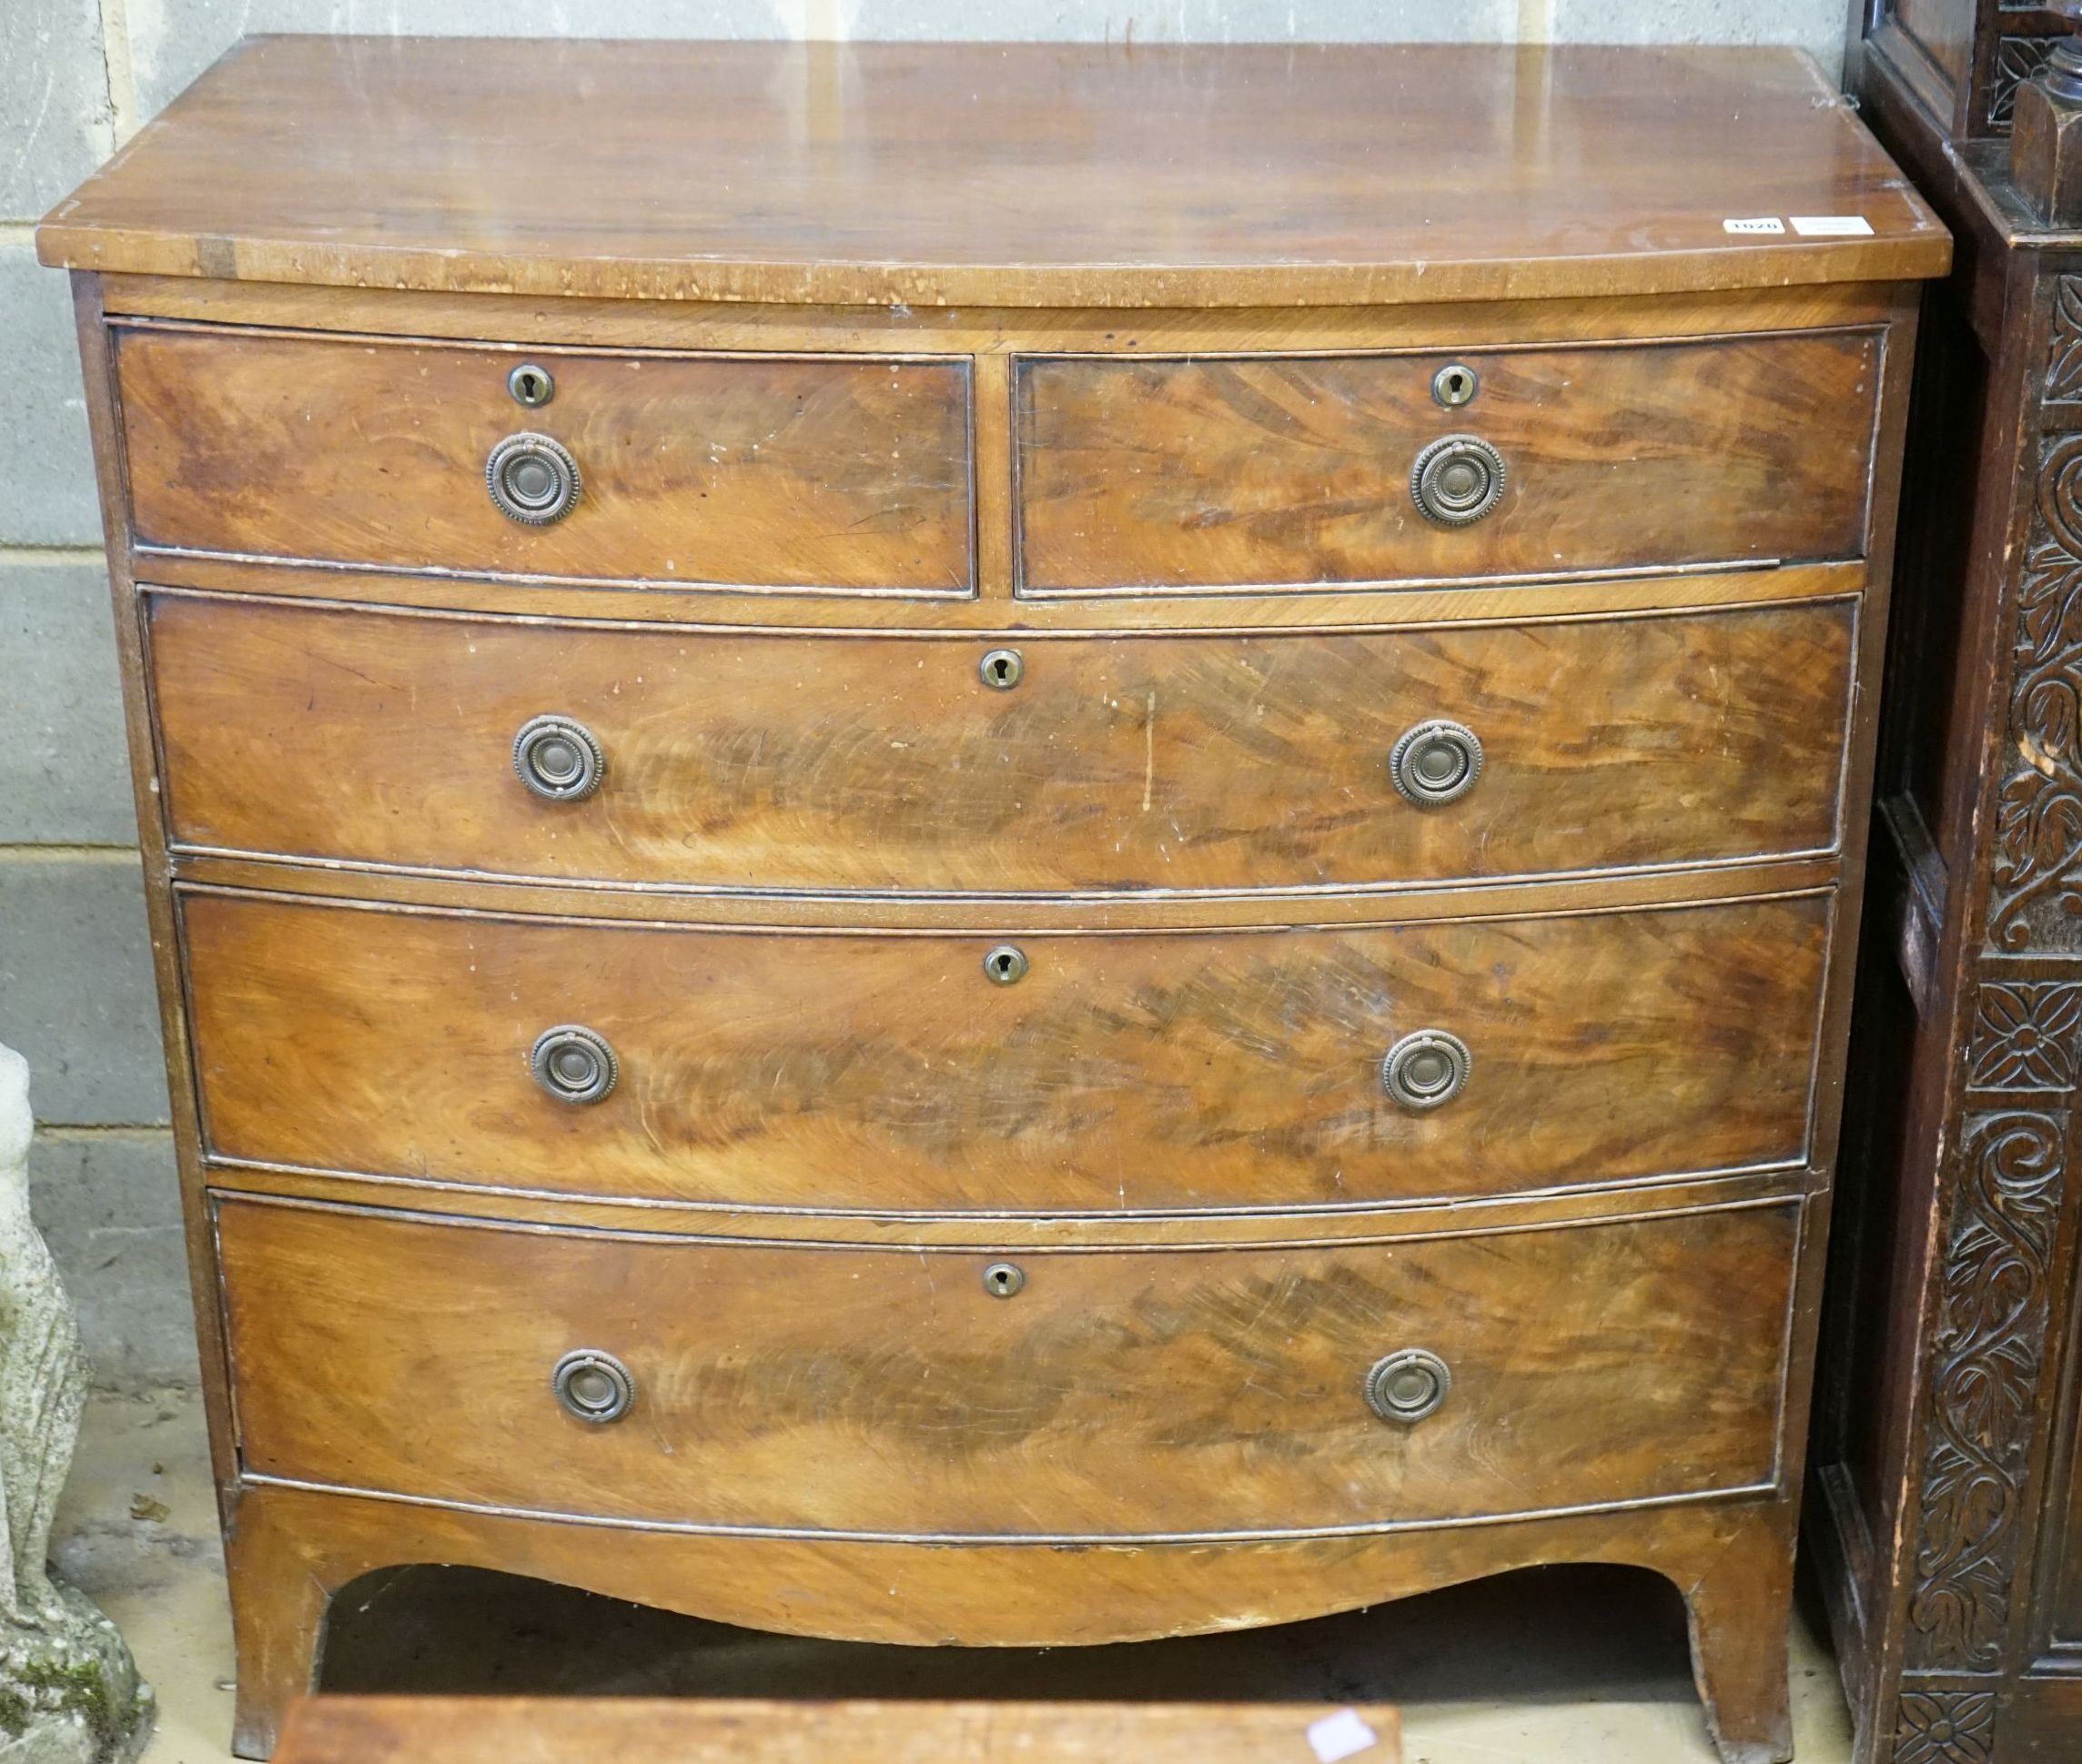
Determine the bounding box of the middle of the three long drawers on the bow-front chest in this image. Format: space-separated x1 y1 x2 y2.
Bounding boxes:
183 893 1830 1212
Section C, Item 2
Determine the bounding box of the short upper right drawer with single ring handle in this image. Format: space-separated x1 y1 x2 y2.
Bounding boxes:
1016 331 1882 593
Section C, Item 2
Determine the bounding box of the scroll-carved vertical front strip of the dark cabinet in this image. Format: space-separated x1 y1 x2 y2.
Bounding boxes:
1880 277 2082 1764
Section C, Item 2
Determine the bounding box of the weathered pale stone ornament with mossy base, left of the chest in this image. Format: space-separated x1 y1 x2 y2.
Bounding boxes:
0 1045 152 1764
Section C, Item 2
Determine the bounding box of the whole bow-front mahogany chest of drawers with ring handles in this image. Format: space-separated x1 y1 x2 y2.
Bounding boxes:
39 37 1949 1764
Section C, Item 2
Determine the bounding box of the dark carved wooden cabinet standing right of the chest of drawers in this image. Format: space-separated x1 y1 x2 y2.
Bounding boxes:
1809 0 2082 1764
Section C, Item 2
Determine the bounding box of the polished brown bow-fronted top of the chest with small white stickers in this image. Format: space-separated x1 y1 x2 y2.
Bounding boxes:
37 37 1949 307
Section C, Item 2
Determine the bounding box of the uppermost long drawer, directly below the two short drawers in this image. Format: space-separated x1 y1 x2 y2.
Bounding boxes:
150 593 1857 893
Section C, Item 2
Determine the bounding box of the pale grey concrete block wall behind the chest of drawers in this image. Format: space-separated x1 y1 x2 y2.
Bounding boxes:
0 0 1844 1385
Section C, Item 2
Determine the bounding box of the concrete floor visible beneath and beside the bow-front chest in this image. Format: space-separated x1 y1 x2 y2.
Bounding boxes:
45 1391 1851 1764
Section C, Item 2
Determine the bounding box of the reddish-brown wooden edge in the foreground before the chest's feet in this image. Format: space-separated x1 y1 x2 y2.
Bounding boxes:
275 1698 1403 1764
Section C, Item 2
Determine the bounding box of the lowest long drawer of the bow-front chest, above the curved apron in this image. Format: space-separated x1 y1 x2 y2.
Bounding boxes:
217 1200 1799 1539
